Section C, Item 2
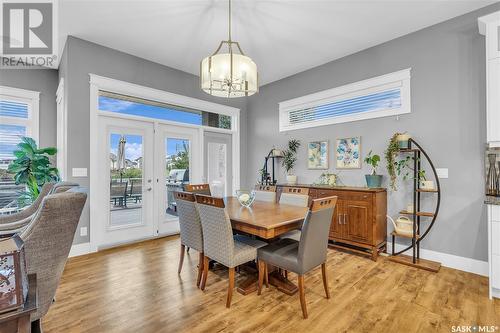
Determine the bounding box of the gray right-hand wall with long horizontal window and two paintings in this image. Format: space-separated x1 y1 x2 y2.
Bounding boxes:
247 4 500 260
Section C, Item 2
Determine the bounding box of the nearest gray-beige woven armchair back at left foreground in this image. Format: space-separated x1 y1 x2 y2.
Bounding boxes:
20 187 87 325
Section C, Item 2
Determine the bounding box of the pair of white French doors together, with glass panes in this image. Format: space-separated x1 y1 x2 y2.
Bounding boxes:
96 116 203 248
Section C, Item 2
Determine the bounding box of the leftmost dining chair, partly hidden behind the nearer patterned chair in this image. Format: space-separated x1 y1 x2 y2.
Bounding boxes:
174 192 203 287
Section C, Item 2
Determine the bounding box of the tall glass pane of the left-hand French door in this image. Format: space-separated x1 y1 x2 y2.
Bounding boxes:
109 133 144 226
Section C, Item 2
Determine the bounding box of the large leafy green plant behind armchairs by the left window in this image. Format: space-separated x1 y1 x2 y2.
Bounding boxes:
7 137 59 206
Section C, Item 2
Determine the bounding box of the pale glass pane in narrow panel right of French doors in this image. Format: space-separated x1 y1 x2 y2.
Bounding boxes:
207 142 227 197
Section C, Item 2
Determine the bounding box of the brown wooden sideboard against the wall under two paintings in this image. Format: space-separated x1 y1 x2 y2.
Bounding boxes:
277 184 387 261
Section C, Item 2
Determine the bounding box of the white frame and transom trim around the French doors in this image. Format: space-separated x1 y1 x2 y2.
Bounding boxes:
89 73 241 252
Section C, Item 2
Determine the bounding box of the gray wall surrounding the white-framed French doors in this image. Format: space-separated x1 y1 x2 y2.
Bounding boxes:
60 36 247 244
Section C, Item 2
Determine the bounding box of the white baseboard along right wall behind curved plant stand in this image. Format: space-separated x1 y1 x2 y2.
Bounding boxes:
387 242 488 276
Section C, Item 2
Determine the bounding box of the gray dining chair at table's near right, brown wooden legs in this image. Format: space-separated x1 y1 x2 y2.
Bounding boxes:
257 197 337 318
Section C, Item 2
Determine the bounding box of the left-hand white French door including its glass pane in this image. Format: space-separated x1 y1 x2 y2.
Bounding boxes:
95 117 156 247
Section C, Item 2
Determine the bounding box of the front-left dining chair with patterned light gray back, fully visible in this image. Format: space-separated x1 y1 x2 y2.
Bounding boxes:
196 194 266 308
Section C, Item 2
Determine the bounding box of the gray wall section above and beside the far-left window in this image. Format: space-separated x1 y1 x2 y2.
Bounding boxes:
0 69 59 147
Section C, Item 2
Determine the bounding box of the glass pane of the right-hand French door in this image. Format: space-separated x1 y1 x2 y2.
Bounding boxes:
165 138 190 220
